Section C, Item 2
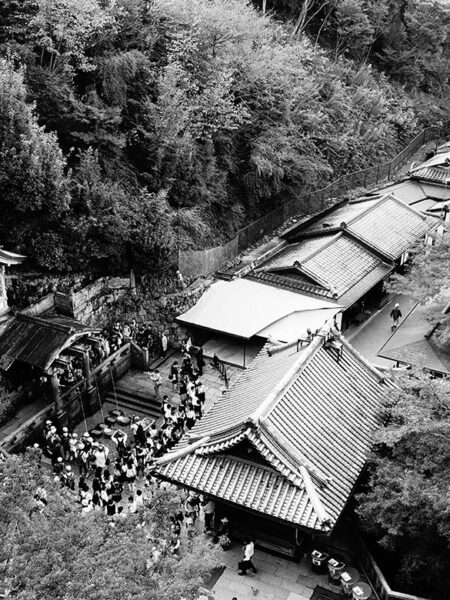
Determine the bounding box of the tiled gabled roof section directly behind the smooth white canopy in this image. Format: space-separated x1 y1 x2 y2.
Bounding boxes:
258 232 391 306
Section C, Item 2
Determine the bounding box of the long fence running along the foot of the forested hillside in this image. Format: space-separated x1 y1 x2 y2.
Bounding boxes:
179 121 450 277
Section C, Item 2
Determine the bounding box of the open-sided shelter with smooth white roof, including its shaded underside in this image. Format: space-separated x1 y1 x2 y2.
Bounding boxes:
177 277 342 367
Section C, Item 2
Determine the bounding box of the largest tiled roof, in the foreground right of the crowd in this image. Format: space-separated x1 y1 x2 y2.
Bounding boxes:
157 332 392 529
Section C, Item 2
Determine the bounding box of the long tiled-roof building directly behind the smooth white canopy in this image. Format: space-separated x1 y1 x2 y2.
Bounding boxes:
253 194 439 329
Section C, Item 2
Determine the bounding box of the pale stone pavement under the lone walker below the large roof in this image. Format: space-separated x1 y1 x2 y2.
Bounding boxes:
213 545 339 600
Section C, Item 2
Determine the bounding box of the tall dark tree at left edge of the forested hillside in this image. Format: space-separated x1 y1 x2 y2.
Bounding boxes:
0 59 70 258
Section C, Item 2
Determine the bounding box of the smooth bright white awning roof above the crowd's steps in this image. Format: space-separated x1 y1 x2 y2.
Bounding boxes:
177 279 341 339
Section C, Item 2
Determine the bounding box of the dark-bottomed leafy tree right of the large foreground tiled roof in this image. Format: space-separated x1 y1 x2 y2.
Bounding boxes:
357 372 450 600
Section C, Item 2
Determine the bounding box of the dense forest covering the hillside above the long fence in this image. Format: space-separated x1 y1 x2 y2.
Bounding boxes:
0 0 450 274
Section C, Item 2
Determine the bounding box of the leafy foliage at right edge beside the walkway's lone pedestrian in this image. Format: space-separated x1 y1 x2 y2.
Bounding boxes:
392 235 450 352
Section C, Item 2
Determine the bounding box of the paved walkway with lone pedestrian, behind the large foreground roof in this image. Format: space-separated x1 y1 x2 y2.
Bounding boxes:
348 295 416 367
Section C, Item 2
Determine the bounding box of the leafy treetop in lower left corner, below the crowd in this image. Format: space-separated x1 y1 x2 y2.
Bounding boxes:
0 452 220 600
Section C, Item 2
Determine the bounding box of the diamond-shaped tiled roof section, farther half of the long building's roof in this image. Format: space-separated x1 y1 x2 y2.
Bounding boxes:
347 195 430 260
